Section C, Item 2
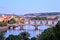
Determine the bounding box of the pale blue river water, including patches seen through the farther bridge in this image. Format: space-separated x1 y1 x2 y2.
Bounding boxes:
4 21 57 37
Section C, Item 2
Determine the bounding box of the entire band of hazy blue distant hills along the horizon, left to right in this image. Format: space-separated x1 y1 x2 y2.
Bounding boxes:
0 12 60 17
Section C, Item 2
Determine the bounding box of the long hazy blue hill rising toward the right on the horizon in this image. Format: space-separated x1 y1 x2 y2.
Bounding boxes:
24 12 60 16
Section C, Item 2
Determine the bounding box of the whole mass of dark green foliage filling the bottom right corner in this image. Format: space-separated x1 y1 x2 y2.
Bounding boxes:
39 21 60 40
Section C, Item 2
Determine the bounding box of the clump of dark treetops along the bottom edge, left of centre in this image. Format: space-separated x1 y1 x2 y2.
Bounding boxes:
6 32 30 40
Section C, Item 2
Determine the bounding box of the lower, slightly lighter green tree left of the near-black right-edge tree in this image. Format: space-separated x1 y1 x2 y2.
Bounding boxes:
39 28 56 40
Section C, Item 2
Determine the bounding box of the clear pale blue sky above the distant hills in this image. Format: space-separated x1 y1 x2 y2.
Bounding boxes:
0 0 60 15
